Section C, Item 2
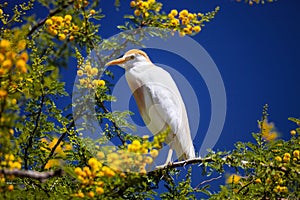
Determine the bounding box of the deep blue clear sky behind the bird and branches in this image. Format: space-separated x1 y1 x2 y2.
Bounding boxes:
4 0 300 197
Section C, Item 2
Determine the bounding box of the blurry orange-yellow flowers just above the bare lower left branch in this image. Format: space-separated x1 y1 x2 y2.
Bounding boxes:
40 137 72 169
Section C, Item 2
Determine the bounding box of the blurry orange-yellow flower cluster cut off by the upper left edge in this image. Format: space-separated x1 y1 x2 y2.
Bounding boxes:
0 39 28 75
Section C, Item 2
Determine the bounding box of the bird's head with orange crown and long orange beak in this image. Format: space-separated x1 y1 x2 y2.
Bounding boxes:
105 49 152 69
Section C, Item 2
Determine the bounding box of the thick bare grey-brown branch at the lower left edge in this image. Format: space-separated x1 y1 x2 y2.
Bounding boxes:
0 169 64 182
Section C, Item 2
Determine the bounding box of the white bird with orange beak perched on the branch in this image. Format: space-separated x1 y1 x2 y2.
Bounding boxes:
106 49 195 164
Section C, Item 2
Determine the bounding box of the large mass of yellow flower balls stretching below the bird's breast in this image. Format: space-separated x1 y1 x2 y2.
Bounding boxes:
74 129 169 198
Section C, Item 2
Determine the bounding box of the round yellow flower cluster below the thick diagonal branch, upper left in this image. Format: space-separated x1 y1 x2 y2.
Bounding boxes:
45 15 79 41
